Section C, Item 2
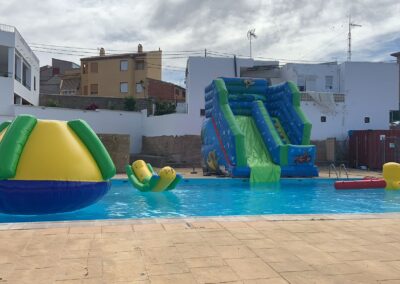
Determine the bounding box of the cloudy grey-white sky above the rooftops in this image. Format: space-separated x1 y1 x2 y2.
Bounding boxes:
0 0 400 84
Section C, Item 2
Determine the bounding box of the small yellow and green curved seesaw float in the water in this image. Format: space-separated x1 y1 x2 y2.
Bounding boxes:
125 160 182 192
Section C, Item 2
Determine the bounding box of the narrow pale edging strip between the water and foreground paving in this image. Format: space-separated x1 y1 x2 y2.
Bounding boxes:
0 213 400 231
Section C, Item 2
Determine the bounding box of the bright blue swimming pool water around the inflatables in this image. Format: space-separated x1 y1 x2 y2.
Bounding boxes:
0 179 400 222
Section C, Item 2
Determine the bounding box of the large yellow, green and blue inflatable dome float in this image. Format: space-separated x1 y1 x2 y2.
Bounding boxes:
0 115 115 215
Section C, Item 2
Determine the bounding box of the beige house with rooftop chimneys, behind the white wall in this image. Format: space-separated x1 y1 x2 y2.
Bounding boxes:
80 44 162 98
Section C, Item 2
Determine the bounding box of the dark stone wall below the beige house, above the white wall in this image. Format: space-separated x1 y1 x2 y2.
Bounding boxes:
39 95 153 115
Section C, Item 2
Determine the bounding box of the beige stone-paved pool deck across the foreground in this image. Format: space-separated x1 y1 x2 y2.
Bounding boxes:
0 168 400 284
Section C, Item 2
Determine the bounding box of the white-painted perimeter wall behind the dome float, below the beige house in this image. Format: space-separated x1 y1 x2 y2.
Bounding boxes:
14 106 146 153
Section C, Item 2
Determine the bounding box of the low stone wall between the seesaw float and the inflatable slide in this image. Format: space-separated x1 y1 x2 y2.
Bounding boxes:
132 135 201 167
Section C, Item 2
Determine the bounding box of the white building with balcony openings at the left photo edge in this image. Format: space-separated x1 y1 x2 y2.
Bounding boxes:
0 24 40 122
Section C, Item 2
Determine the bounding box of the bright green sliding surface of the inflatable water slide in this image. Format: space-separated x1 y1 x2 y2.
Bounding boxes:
235 115 281 183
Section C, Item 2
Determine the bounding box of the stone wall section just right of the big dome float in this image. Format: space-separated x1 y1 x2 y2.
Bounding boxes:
97 134 130 173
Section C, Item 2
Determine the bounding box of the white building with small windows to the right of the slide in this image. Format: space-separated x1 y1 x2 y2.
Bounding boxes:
281 62 399 140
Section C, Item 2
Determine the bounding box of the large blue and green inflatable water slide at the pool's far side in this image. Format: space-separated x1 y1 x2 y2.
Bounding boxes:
201 78 318 182
